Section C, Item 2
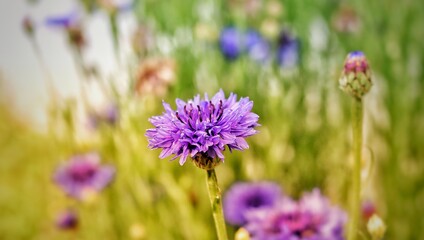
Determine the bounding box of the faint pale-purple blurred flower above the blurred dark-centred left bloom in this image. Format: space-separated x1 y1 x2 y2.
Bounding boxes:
88 103 119 129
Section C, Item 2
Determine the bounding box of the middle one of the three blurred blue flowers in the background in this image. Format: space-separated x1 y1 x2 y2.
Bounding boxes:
244 29 270 62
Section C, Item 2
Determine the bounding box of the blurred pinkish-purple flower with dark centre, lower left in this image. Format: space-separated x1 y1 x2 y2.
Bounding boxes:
54 153 115 200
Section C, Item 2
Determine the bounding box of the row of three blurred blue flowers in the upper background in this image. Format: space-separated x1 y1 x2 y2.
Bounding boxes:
219 27 300 68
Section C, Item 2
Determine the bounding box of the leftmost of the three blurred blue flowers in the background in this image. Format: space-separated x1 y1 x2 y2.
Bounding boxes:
219 27 243 60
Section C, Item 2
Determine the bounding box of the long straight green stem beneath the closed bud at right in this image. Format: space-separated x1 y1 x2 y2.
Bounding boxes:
347 99 363 240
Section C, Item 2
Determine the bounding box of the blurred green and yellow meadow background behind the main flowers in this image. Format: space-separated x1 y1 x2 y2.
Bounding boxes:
0 0 424 239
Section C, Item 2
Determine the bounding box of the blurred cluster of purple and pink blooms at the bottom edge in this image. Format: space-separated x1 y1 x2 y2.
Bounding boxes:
224 183 347 240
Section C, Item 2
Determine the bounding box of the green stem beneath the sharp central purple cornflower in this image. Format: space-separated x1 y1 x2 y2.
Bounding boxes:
206 169 228 240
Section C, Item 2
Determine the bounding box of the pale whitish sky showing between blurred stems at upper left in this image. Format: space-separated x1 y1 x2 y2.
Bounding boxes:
0 0 136 129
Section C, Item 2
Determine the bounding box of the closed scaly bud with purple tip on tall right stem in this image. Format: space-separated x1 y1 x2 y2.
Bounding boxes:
339 51 372 100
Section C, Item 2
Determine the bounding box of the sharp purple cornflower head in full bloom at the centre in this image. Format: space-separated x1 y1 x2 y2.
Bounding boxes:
146 90 259 169
